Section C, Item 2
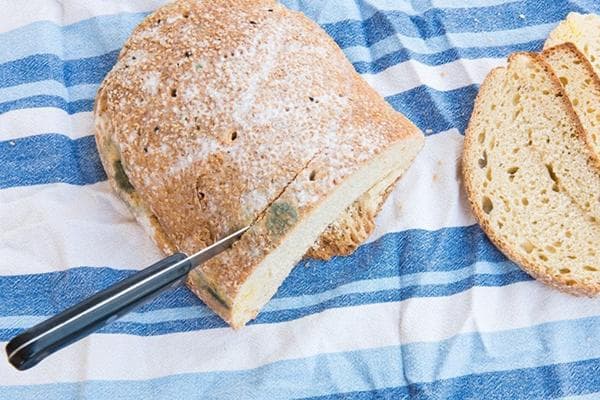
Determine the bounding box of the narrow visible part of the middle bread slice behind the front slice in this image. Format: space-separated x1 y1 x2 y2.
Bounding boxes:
542 43 600 170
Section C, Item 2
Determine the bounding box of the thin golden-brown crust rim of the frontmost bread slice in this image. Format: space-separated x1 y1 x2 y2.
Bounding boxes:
462 52 600 297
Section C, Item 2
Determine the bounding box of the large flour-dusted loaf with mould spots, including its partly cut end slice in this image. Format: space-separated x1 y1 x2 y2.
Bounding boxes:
95 0 423 327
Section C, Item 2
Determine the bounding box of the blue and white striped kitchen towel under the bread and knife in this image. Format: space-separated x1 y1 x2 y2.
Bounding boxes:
0 0 600 400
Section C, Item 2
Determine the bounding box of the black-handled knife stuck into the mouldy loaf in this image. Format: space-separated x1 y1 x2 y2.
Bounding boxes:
6 226 249 370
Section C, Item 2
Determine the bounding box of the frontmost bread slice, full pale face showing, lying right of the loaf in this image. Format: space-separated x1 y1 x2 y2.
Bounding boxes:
463 53 600 295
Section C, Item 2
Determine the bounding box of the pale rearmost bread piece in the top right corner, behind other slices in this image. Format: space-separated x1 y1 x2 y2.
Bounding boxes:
544 12 600 75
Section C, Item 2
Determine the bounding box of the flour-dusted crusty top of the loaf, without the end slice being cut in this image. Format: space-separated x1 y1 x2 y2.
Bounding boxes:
95 0 415 252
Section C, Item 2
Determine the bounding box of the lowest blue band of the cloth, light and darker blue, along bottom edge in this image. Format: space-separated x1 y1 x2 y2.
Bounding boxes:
0 317 600 400
